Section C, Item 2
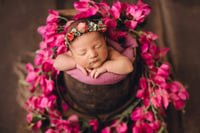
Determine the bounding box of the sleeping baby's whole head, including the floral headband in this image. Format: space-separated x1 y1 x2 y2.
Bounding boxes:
66 19 108 69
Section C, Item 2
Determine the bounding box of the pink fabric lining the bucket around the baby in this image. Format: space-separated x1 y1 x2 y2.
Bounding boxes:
66 35 138 85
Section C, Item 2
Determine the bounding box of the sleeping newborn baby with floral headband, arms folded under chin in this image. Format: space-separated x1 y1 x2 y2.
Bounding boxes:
54 18 134 78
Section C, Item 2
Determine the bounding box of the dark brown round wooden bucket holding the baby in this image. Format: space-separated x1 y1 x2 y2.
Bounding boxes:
57 48 140 115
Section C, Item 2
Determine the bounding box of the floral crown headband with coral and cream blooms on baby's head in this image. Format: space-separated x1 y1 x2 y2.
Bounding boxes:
65 20 106 45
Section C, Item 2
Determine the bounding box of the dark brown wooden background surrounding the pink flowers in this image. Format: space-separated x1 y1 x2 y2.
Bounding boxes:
0 0 200 133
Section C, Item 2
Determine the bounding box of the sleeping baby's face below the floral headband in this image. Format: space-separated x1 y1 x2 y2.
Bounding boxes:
70 32 108 69
